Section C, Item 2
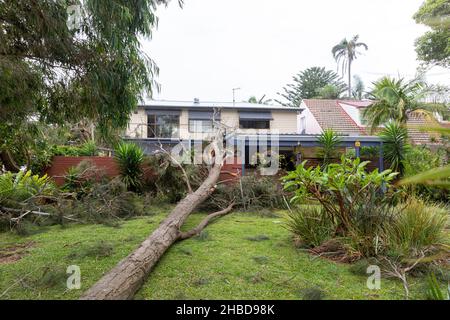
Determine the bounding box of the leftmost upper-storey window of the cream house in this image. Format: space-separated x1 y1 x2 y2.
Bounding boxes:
147 114 180 138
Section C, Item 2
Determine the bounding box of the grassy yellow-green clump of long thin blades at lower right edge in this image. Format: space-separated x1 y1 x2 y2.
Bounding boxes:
387 199 448 258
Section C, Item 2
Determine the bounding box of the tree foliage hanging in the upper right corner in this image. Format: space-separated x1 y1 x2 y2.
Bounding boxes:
414 0 450 67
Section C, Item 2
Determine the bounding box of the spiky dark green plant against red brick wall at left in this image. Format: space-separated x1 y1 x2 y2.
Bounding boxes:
115 143 144 191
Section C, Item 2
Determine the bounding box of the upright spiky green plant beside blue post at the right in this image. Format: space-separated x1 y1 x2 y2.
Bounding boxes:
379 122 411 174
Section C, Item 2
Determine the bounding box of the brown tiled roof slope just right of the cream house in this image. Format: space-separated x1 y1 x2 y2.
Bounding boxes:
303 99 366 135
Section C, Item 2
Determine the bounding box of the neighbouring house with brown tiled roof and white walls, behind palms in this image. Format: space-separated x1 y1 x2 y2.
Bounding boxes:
299 99 439 146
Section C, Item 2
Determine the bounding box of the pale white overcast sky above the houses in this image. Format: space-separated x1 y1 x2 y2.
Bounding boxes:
144 0 450 101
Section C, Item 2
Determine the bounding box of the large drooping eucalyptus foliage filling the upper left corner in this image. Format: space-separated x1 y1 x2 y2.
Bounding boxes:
0 0 179 170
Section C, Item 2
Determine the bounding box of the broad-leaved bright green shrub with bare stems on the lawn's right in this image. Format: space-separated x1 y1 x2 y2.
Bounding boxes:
283 156 397 235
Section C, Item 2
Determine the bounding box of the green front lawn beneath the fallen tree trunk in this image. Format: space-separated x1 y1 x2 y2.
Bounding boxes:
0 208 432 299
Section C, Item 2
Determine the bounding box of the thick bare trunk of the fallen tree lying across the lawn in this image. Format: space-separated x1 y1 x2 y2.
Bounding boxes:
81 162 222 300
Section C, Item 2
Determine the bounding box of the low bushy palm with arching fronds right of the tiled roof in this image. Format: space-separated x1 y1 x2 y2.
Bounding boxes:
364 77 442 131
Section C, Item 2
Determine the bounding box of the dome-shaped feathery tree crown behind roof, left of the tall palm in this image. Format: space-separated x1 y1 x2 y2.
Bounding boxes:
279 67 347 107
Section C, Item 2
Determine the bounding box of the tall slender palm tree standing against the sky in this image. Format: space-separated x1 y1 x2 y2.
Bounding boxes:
331 35 369 98
